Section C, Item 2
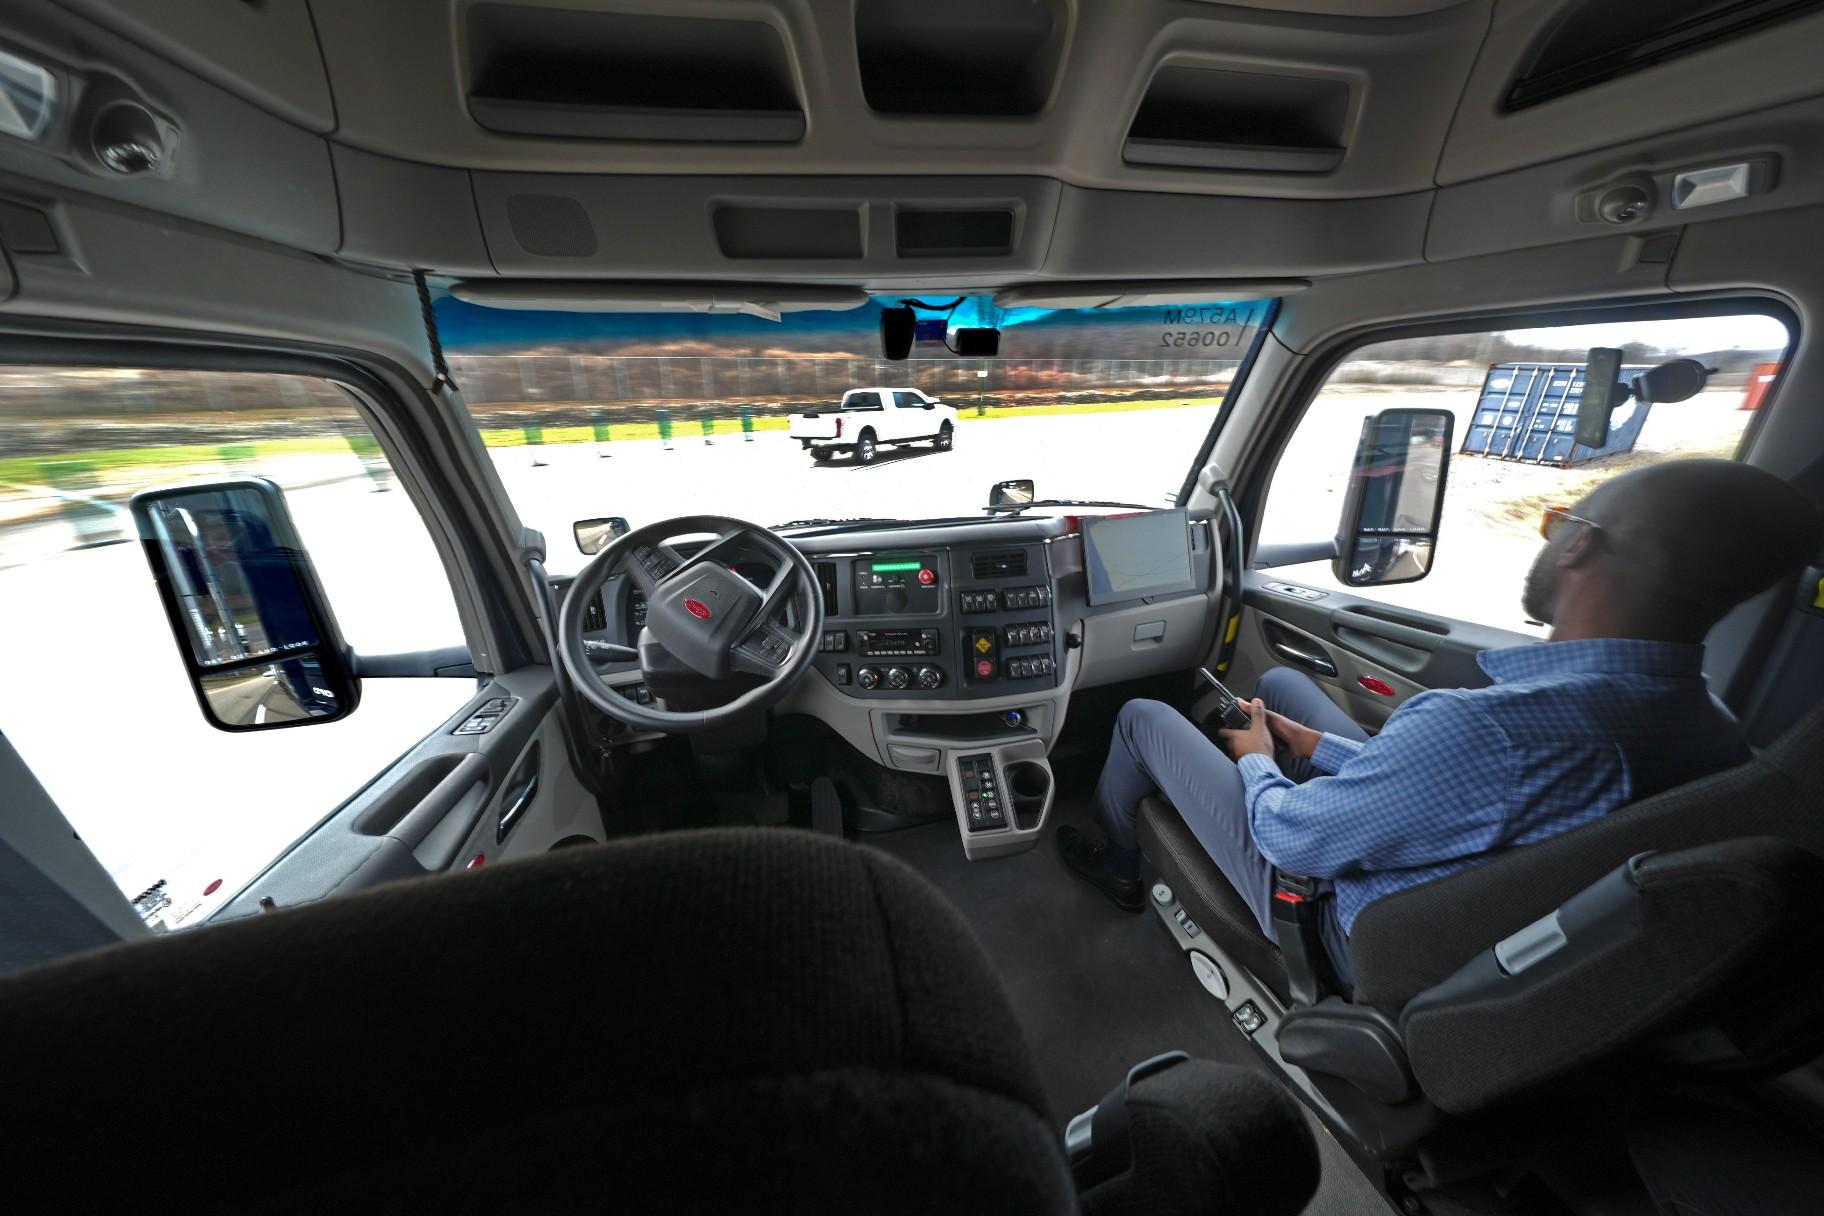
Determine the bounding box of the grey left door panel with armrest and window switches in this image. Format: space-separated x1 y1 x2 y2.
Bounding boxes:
213 667 604 921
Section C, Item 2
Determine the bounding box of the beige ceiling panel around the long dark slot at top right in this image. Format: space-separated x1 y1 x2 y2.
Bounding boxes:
1437 0 1824 184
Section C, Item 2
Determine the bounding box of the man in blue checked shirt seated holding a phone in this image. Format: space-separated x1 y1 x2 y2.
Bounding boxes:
1058 459 1824 983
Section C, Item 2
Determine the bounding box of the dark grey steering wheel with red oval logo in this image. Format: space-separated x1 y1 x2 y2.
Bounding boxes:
558 516 823 735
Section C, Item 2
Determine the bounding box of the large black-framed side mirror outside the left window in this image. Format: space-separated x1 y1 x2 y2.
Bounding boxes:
133 478 361 731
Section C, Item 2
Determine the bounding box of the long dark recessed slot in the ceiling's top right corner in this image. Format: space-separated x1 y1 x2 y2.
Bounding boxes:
1507 0 1824 111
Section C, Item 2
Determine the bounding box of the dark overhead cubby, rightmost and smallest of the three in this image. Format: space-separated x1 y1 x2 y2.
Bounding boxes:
1122 66 1350 173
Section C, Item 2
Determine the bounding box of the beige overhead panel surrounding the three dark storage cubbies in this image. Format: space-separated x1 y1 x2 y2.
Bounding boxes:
312 0 1492 197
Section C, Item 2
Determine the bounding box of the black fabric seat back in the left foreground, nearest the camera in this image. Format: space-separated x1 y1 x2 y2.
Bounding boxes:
0 830 1076 1212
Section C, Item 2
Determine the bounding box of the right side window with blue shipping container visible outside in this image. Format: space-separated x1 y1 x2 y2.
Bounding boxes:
1260 314 1789 636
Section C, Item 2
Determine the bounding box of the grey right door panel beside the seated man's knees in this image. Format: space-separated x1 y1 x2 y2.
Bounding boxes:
1229 571 1536 731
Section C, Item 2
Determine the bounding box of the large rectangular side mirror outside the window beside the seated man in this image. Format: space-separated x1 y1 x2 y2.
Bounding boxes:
1332 410 1456 587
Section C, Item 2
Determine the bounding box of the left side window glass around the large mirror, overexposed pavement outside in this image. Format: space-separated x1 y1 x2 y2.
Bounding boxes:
0 366 474 928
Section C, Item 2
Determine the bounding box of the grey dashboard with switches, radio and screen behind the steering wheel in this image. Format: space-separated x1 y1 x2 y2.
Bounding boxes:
554 512 1220 859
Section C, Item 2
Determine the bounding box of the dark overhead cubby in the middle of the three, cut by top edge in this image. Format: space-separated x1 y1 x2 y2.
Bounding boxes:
855 0 1067 117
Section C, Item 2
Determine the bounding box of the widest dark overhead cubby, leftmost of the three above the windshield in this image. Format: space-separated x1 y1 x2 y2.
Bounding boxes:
469 4 804 144
